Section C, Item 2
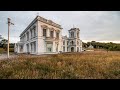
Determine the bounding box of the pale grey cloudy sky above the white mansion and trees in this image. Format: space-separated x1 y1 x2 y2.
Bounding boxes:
0 11 120 43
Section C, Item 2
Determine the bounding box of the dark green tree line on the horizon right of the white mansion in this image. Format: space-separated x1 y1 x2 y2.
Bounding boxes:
83 41 120 51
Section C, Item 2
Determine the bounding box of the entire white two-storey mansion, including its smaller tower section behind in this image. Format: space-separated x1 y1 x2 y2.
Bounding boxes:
14 16 82 55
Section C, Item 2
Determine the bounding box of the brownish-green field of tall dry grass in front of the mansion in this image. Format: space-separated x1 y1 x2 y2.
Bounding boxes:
0 51 120 79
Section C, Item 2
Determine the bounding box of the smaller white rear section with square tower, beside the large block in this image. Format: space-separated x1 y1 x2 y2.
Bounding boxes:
62 28 82 52
